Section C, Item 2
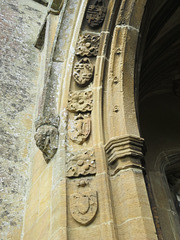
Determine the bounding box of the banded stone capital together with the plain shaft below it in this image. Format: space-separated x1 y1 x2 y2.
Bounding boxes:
105 135 157 240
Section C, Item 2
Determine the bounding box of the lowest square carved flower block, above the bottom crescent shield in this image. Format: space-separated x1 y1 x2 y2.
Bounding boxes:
67 150 96 177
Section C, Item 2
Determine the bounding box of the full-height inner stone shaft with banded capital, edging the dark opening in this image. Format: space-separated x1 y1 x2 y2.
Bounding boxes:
104 0 157 240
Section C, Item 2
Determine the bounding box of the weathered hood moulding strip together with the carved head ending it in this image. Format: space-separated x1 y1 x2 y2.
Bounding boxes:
34 0 64 163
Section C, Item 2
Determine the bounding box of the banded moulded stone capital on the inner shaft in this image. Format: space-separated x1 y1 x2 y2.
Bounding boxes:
105 135 144 175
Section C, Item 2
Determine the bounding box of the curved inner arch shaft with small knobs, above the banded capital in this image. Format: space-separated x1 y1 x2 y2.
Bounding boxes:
105 0 147 142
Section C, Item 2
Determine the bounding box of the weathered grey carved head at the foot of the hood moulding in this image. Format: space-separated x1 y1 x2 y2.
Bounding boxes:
34 125 59 163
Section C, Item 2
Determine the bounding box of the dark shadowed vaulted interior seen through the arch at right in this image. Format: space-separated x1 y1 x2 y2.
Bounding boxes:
136 1 180 239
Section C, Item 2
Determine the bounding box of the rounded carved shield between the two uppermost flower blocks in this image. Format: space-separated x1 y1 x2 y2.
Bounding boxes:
73 58 93 86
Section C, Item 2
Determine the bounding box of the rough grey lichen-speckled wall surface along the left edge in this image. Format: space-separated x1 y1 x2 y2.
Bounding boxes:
0 0 46 240
